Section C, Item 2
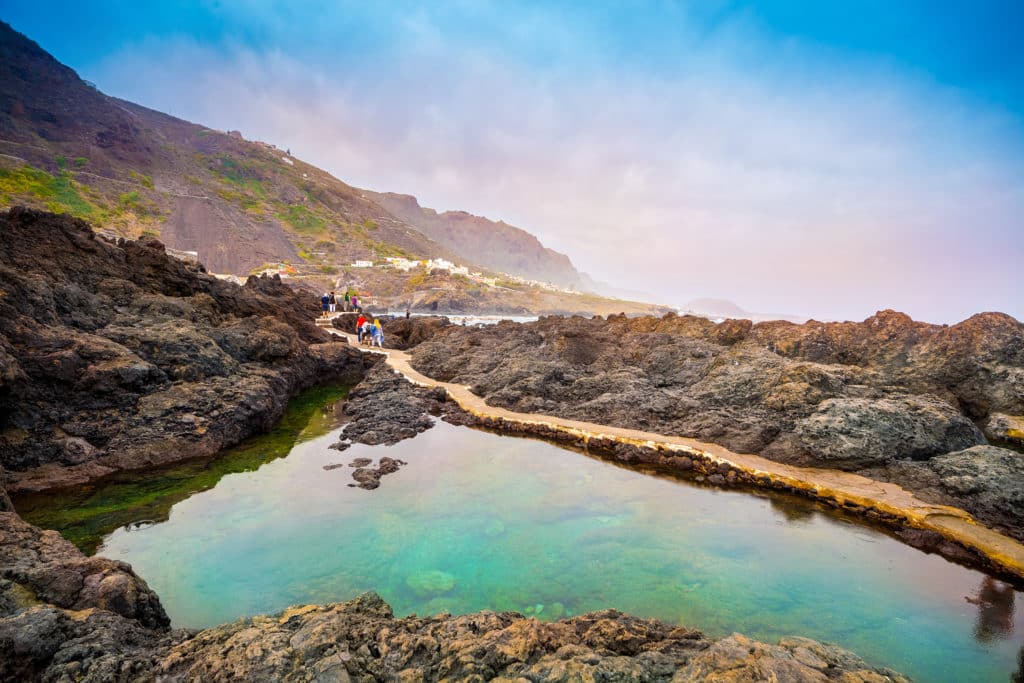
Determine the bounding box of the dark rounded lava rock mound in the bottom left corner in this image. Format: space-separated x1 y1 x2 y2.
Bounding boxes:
0 512 187 682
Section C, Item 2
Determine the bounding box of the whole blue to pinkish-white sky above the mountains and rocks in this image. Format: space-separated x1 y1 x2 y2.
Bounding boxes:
0 0 1024 323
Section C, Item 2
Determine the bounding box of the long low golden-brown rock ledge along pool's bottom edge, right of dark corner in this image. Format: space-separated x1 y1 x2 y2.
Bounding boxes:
151 593 907 683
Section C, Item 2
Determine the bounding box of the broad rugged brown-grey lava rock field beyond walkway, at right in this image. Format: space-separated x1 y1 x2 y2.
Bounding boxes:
409 311 1024 539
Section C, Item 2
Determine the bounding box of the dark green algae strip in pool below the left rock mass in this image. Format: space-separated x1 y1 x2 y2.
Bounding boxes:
13 385 348 555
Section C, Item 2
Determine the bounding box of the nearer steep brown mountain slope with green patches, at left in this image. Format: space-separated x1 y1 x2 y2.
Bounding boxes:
0 23 455 274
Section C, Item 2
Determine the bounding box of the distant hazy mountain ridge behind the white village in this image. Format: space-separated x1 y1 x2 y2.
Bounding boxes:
365 190 583 288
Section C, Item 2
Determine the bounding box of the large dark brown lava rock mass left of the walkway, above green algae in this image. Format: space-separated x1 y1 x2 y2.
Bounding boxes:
0 208 375 492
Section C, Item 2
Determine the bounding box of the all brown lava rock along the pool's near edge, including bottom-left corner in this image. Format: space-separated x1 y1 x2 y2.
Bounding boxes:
0 512 906 683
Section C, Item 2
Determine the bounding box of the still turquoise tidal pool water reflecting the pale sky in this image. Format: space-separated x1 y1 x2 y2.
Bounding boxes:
15 395 1024 681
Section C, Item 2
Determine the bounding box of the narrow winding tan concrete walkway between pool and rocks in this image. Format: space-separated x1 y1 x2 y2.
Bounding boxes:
330 330 1024 579
